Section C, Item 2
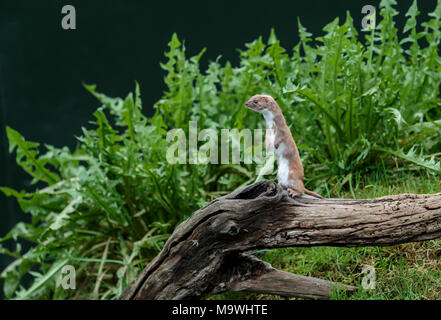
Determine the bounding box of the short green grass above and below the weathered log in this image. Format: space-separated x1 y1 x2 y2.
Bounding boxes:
211 171 441 300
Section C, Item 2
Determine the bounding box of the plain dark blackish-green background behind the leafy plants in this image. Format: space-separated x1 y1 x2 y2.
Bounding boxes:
0 0 436 297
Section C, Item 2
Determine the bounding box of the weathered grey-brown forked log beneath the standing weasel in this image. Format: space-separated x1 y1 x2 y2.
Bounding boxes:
121 180 441 299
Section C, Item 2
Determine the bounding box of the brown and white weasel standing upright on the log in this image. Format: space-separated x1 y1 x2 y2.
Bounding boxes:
245 94 323 198
